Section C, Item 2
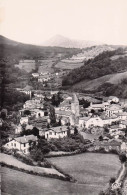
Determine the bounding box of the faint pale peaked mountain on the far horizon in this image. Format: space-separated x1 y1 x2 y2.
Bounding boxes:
42 35 102 48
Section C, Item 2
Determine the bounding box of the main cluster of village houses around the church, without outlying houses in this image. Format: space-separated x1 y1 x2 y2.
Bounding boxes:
2 92 127 153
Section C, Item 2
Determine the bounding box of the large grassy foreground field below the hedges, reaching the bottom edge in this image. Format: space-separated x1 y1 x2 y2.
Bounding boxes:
1 153 120 195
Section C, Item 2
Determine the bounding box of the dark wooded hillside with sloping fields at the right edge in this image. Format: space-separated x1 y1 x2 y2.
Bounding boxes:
62 48 127 97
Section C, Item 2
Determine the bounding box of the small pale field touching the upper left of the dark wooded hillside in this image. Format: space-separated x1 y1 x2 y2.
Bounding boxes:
55 61 83 70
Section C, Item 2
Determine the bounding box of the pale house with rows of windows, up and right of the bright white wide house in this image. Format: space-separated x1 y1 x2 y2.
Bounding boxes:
106 104 123 117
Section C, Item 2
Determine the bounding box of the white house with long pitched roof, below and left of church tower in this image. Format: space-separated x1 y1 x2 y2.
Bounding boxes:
45 126 68 139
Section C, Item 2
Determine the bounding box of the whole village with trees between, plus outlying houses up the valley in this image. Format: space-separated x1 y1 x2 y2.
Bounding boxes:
0 73 127 155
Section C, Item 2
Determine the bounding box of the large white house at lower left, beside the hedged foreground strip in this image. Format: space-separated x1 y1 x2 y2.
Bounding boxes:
4 135 37 154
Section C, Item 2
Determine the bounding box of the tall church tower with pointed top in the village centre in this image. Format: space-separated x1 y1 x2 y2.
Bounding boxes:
70 93 79 125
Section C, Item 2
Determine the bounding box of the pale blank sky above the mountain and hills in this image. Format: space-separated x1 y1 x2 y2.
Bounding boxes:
0 0 127 45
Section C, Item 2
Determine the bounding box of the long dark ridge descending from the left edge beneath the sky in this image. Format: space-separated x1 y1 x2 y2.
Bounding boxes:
0 35 81 60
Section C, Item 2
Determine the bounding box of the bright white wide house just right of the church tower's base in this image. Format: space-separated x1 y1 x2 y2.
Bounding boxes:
79 115 104 128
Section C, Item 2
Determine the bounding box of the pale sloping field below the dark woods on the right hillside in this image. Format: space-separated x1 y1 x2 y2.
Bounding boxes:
73 71 127 91
